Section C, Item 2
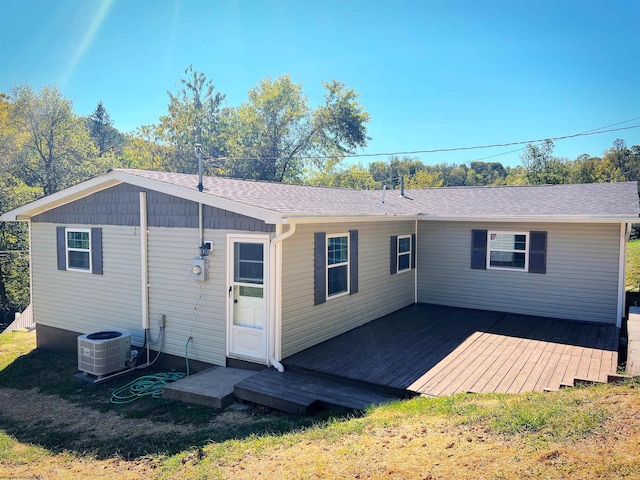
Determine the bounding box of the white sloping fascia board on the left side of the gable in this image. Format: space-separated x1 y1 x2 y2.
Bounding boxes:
0 173 121 222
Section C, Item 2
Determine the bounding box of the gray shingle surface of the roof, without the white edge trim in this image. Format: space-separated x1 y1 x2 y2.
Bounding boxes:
117 170 640 218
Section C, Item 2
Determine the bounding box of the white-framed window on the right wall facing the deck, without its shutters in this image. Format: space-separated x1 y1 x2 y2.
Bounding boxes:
487 231 529 272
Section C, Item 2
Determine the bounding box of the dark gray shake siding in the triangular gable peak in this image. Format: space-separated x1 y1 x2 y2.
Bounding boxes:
32 184 274 232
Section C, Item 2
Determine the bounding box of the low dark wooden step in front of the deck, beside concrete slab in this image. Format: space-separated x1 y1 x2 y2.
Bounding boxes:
234 368 398 415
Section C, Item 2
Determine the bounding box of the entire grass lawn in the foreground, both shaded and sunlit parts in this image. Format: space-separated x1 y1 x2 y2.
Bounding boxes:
0 332 640 480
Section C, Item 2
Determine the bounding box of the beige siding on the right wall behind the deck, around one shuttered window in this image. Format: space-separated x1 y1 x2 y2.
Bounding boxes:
418 222 620 323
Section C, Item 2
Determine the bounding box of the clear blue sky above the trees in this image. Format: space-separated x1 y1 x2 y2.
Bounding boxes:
0 0 640 166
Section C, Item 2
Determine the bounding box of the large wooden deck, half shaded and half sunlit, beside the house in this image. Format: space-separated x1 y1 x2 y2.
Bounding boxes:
283 304 618 396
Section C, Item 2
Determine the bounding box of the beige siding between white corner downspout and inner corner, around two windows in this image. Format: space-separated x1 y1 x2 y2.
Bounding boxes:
282 222 415 358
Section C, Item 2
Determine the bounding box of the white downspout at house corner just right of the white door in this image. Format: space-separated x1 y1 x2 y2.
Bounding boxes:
268 223 296 373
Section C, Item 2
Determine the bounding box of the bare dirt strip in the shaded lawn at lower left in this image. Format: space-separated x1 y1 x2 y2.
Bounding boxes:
0 388 278 458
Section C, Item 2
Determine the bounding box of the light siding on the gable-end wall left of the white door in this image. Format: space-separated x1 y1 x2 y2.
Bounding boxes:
31 223 238 365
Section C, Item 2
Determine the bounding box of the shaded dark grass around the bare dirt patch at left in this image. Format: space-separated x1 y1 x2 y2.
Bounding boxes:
0 349 352 459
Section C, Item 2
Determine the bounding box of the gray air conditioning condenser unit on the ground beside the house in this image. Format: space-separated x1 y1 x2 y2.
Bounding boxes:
78 330 131 377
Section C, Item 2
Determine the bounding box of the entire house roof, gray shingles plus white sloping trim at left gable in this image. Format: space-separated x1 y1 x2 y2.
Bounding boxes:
1 169 640 223
